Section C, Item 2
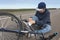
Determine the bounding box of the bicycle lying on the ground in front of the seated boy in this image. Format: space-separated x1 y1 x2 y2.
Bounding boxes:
0 12 57 40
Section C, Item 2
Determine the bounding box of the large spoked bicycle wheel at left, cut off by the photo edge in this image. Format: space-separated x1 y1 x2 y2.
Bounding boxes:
0 12 22 40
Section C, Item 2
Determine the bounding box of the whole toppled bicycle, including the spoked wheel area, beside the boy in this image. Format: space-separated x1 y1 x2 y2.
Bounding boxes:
0 12 57 40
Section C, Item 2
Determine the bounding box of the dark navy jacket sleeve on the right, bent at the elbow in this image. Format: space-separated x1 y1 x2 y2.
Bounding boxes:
36 12 50 26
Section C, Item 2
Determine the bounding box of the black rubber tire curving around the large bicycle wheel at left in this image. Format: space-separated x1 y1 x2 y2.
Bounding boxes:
0 12 22 40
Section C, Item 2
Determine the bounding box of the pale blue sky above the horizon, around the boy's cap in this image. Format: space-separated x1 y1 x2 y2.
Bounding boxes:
0 0 60 9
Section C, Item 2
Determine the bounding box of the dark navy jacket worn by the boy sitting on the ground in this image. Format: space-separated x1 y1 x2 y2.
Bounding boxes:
35 9 51 26
